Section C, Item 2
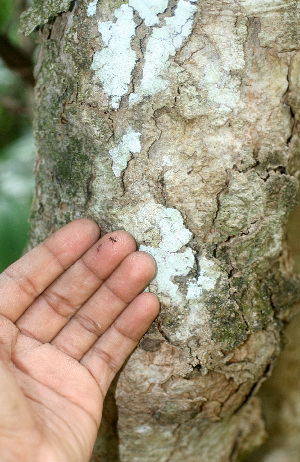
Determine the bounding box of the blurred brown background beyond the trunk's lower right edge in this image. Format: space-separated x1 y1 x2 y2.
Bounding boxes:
247 189 300 462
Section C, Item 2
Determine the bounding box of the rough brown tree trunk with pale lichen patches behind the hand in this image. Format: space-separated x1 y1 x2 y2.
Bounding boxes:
23 0 300 462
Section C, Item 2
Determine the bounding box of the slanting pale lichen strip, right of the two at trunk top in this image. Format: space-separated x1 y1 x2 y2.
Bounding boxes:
129 0 197 104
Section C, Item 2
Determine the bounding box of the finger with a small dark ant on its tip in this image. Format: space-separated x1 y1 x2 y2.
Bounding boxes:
16 231 136 342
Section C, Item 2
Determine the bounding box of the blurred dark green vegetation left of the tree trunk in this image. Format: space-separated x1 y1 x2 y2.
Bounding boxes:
0 0 35 272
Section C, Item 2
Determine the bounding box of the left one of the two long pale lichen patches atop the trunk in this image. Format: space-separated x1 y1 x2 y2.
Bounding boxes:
91 5 136 109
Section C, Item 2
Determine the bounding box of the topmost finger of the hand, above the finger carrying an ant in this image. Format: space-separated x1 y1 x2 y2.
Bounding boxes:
0 219 100 322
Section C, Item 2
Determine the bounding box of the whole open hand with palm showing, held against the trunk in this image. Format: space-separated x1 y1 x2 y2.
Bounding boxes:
0 219 159 462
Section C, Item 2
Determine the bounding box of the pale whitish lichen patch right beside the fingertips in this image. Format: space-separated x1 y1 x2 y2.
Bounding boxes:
119 198 222 304
